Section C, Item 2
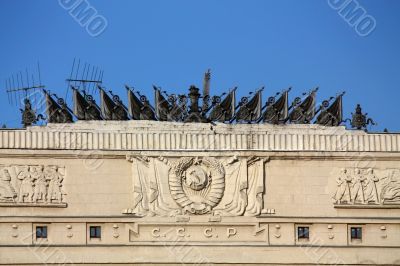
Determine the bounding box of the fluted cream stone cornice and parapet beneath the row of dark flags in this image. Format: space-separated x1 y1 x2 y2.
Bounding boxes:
0 121 400 152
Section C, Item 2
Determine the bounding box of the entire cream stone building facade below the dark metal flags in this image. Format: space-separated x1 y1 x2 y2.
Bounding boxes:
0 121 400 265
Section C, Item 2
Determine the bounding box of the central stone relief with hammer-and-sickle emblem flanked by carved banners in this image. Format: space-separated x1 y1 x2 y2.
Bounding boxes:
123 155 267 216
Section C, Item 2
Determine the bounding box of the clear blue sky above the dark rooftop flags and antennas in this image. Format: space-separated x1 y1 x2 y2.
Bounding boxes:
0 0 400 131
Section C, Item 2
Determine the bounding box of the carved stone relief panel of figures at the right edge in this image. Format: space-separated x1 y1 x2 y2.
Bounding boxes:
332 168 400 205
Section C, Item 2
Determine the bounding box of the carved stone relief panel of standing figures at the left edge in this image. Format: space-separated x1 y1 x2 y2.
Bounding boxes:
0 165 66 207
